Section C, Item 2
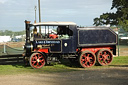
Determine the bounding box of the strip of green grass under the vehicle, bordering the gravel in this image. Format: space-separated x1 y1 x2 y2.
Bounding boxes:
0 56 128 76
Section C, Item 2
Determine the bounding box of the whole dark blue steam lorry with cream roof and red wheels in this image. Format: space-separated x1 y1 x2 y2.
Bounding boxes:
24 21 117 68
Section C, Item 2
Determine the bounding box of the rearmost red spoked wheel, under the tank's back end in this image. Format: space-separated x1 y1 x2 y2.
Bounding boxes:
97 49 113 65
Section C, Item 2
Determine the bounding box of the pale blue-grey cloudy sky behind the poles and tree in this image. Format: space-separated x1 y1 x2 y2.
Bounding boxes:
0 0 116 31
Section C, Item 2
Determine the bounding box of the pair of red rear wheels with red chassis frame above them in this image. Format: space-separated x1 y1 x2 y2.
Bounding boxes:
76 47 113 67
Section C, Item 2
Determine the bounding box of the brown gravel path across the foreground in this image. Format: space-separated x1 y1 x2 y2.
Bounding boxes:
0 66 128 85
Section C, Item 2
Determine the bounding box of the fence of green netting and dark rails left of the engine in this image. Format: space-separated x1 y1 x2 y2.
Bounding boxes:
0 45 24 65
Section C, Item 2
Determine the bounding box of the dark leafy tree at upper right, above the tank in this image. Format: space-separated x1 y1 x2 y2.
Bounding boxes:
94 0 128 31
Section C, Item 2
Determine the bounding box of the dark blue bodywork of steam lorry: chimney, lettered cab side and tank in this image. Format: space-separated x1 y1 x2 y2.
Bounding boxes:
25 20 117 55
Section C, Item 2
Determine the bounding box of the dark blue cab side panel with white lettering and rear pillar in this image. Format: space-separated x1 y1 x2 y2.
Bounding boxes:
33 26 77 53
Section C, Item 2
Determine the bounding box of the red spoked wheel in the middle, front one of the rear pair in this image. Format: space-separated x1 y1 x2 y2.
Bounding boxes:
79 51 96 68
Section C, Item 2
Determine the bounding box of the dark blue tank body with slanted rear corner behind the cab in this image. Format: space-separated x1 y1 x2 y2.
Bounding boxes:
78 27 117 47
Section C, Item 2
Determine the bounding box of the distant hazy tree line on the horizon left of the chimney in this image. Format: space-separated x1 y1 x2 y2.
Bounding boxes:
0 30 25 36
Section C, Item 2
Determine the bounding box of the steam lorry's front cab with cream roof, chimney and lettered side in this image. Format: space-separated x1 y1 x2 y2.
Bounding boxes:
25 21 77 68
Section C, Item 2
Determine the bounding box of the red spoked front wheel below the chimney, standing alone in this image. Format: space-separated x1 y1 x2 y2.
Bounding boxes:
30 53 45 68
